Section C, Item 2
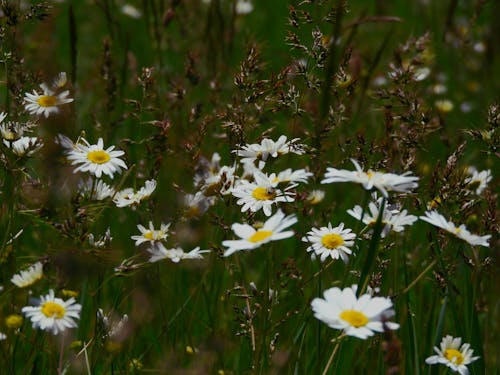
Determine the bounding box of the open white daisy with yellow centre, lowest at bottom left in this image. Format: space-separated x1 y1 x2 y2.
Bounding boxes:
22 289 82 335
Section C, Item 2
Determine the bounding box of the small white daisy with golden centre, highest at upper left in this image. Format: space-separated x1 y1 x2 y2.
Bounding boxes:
24 83 73 117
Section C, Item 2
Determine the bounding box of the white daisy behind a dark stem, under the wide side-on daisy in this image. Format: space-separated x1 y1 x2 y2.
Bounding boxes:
347 194 418 238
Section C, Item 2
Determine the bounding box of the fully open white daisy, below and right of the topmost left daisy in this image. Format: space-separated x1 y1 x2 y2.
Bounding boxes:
67 138 127 178
